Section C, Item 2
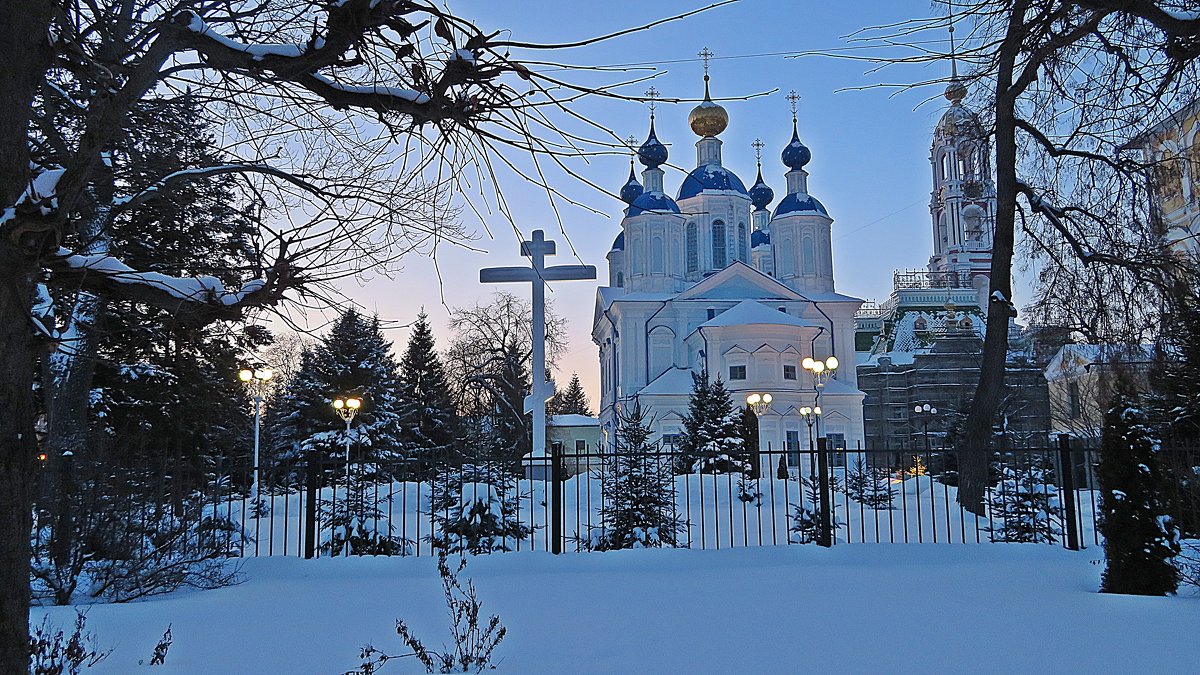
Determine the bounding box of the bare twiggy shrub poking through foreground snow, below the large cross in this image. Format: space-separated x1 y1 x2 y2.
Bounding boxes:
350 552 508 675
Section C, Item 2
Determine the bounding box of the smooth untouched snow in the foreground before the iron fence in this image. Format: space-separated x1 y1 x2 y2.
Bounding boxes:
34 544 1200 675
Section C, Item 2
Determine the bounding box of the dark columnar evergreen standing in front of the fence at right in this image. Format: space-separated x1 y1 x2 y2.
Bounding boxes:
1096 395 1180 596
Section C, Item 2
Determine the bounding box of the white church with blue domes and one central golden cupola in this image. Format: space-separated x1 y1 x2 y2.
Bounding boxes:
592 73 864 459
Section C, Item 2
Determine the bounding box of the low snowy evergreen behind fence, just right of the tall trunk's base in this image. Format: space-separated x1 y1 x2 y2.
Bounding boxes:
986 455 1062 544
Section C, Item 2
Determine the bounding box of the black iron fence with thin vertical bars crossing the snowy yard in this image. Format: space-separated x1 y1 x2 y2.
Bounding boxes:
40 437 1200 557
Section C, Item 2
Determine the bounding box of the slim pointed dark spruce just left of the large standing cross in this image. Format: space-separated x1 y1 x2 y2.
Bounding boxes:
400 310 460 476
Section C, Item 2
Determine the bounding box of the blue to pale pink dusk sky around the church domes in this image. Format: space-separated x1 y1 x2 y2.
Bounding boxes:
331 0 1022 401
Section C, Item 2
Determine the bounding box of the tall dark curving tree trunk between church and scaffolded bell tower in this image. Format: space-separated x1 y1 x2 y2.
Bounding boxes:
959 0 1028 515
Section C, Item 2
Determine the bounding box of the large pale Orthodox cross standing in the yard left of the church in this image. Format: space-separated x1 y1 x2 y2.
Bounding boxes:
479 229 596 458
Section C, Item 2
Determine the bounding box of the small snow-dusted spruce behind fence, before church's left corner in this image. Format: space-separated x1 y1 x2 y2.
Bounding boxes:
581 402 683 551
